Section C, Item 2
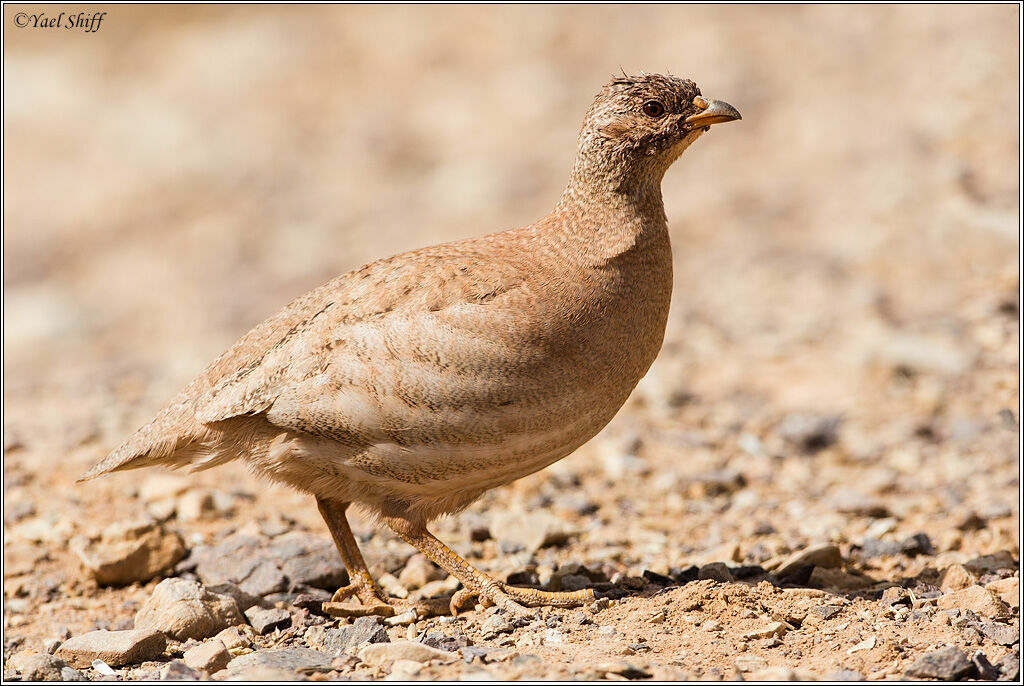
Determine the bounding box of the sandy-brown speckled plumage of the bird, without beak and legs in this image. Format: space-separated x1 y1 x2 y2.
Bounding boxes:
84 75 737 618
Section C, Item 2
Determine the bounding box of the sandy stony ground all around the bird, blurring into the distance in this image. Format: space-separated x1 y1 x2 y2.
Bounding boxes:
3 6 1020 680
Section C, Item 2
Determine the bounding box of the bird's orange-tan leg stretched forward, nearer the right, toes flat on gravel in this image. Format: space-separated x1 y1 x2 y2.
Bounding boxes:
385 517 594 616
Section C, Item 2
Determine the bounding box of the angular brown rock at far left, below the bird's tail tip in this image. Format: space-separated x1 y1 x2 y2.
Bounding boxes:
70 522 185 586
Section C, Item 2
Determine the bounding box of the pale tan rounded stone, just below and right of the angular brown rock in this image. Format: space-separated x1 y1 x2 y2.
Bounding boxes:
135 578 246 641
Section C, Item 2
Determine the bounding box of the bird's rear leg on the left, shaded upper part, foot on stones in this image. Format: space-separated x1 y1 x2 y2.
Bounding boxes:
316 498 446 617
